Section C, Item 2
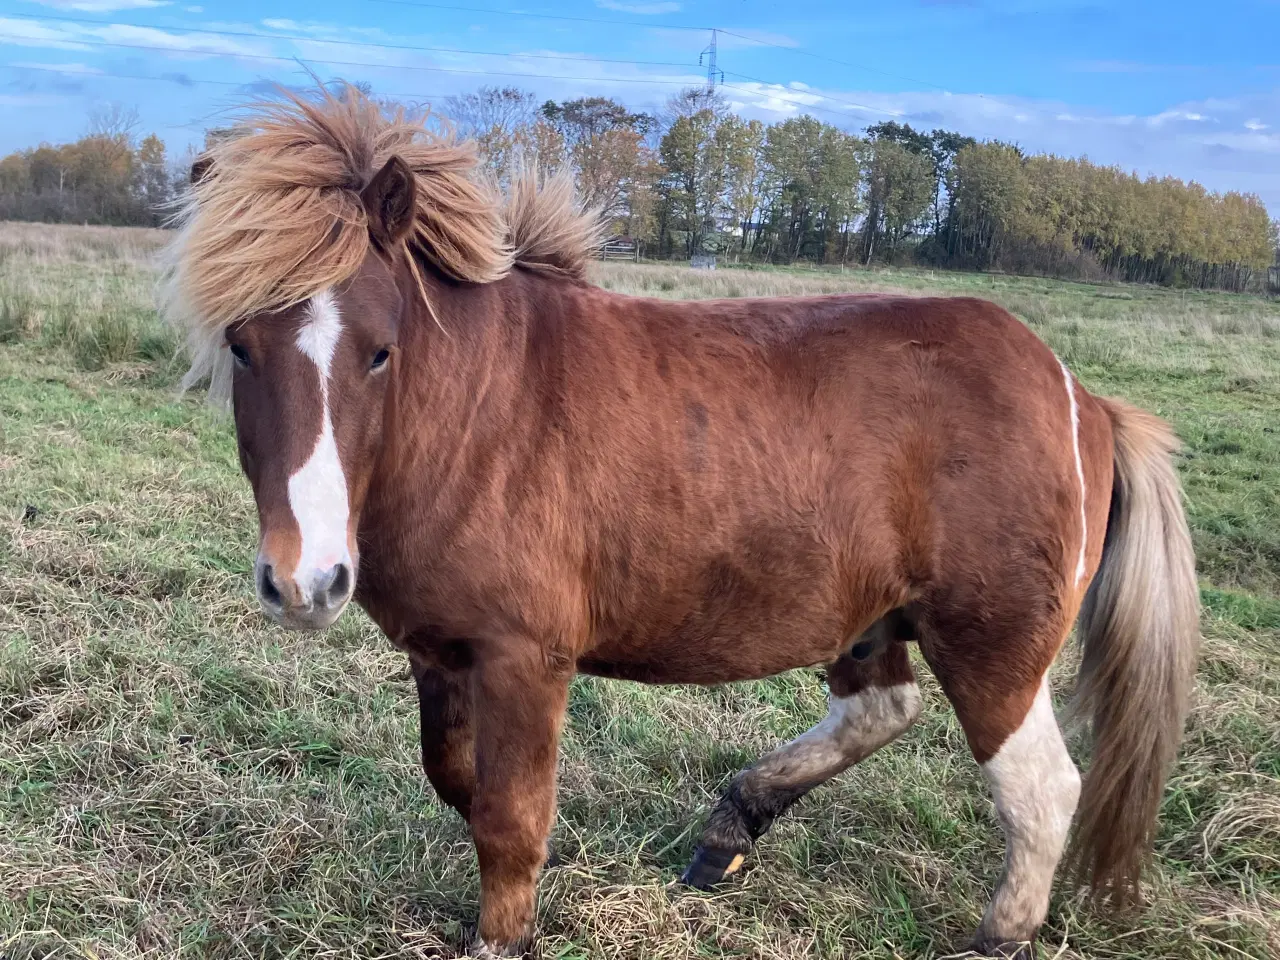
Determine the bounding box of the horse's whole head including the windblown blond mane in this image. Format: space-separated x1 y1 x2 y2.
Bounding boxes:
166 86 599 628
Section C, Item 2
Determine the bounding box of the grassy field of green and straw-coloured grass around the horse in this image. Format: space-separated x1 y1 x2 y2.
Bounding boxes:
0 225 1280 960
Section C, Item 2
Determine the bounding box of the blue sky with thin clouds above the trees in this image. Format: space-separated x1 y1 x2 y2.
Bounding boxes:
0 0 1280 218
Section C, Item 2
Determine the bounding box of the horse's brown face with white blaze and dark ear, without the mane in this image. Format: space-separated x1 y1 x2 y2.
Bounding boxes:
225 157 415 630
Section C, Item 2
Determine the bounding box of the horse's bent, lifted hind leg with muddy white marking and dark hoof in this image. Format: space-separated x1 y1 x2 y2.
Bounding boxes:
682 619 920 890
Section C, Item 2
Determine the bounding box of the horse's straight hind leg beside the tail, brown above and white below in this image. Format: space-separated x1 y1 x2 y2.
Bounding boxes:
920 620 1080 960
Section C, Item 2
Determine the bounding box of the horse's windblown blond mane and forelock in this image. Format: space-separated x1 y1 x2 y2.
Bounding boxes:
163 84 602 394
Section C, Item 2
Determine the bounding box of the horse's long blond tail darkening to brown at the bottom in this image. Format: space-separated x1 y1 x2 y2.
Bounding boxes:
1073 401 1199 901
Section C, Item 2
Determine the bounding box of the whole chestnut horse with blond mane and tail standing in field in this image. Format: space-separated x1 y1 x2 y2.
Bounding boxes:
169 88 1198 956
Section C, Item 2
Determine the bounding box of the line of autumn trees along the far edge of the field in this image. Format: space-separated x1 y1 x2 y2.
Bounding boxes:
0 87 1277 291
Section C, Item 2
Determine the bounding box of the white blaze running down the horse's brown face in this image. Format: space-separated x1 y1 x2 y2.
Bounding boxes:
289 291 349 586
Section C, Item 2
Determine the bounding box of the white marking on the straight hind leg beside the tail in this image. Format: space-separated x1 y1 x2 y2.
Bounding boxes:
979 678 1080 942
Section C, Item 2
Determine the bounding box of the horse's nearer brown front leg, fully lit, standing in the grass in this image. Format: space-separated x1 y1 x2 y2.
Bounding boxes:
471 640 572 956
